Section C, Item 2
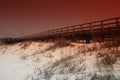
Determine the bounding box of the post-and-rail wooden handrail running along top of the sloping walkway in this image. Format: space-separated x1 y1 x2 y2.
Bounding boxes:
13 17 120 38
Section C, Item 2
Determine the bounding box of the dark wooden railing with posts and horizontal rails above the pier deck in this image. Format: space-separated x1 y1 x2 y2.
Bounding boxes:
26 17 120 38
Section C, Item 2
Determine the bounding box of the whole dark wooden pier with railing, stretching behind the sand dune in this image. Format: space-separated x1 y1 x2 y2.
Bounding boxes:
1 17 120 43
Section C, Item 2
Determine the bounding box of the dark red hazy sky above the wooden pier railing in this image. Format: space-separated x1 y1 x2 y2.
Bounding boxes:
0 0 120 38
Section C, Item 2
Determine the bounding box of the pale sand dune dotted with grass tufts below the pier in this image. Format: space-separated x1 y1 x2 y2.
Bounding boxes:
0 41 120 80
